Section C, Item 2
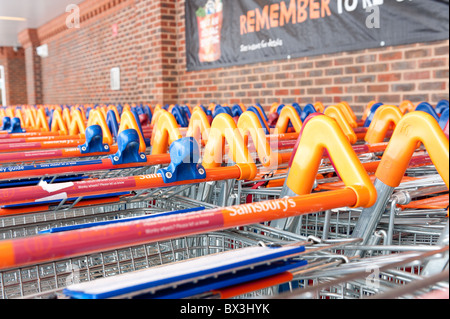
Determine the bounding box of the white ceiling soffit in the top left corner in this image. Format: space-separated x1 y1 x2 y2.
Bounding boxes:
0 0 84 47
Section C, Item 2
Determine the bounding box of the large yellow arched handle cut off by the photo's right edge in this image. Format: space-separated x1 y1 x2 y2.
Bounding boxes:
375 111 449 188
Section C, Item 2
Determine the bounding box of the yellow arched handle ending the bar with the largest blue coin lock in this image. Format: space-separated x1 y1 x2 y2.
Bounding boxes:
203 113 257 180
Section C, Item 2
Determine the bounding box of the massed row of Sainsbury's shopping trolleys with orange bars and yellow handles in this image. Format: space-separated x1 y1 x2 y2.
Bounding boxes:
0 101 449 299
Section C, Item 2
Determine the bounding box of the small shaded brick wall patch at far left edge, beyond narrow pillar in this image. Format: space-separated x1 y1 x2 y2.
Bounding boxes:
0 47 27 105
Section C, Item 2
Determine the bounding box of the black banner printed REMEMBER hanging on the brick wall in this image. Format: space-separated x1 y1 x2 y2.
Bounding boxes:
185 0 449 70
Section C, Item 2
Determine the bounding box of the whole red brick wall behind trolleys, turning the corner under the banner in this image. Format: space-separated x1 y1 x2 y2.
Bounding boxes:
20 0 449 113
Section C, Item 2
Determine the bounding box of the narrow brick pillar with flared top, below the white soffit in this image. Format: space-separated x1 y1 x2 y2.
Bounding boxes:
19 29 44 105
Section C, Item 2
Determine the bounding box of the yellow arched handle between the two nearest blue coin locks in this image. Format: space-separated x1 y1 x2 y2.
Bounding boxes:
149 109 182 155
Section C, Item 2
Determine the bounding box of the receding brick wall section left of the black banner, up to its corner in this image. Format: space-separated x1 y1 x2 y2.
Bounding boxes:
25 0 177 104
